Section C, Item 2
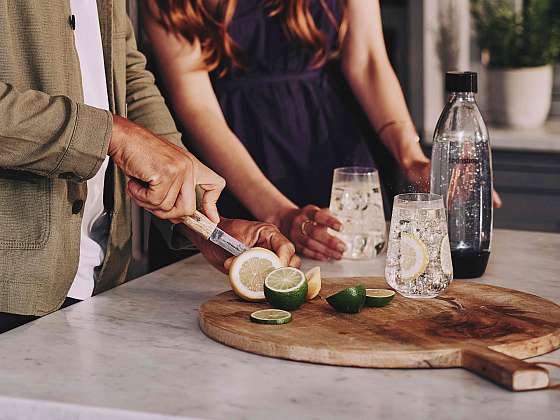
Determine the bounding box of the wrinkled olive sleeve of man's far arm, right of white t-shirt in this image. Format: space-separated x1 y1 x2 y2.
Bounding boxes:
126 19 184 147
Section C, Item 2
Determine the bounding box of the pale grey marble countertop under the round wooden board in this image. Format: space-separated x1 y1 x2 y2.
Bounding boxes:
0 230 560 420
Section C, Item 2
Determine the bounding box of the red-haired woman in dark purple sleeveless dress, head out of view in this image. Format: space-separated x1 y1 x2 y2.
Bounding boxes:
144 0 429 260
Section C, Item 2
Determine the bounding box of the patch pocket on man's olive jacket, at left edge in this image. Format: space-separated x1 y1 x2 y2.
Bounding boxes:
0 170 51 249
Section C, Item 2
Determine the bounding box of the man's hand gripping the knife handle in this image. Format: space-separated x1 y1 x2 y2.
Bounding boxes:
109 116 225 223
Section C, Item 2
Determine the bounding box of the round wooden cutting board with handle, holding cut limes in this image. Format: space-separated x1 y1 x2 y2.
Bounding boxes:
200 277 560 391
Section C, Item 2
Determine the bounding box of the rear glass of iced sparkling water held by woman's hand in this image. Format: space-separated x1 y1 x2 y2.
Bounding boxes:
330 166 386 260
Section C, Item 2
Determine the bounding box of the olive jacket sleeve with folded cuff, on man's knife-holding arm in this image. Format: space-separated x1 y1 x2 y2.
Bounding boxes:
0 81 112 182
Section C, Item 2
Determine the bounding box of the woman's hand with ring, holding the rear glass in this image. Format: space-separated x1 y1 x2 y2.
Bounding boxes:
281 205 346 261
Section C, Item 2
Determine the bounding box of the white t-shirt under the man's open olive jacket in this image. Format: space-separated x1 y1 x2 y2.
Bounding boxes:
68 0 110 300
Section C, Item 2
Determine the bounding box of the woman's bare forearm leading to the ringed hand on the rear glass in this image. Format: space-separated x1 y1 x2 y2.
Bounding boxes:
175 106 297 224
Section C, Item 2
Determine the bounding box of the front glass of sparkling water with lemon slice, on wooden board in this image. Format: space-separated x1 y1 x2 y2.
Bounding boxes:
385 193 453 298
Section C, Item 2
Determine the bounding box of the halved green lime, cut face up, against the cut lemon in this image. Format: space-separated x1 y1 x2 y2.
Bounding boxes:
264 267 307 310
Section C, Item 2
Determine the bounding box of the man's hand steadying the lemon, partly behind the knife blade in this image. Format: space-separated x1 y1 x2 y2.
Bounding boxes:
179 218 301 273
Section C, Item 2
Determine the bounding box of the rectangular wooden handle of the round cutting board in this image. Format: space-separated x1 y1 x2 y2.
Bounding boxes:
462 346 549 391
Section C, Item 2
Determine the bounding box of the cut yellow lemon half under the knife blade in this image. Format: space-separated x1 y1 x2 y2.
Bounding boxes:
229 248 282 302
